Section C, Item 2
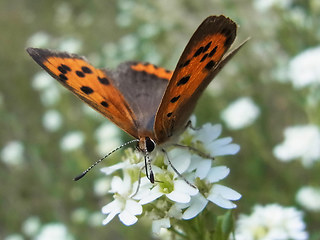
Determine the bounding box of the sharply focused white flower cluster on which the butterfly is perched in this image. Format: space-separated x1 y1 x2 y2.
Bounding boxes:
101 121 241 233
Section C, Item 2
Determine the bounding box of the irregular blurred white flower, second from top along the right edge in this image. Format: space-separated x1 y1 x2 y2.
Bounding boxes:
273 125 320 167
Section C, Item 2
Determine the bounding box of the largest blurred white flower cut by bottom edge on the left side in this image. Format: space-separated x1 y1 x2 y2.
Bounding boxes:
35 223 74 240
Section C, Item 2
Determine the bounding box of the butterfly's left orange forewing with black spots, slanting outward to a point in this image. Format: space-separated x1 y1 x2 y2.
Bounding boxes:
27 48 138 138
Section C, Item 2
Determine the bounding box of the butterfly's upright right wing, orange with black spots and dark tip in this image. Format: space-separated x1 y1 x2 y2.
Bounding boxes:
154 16 237 143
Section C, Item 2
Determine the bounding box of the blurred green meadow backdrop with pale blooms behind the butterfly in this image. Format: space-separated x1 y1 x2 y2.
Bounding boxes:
0 0 320 239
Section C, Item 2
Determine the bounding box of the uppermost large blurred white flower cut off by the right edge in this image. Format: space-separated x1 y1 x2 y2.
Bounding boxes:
288 47 320 89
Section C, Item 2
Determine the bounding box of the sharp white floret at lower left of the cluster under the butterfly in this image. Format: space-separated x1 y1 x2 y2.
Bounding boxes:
102 172 142 226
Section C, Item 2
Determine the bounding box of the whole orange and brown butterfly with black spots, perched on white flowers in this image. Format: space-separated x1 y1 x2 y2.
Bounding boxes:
27 15 245 182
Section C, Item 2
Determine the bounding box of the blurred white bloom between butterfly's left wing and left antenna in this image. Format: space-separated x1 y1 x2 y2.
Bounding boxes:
94 121 121 156
